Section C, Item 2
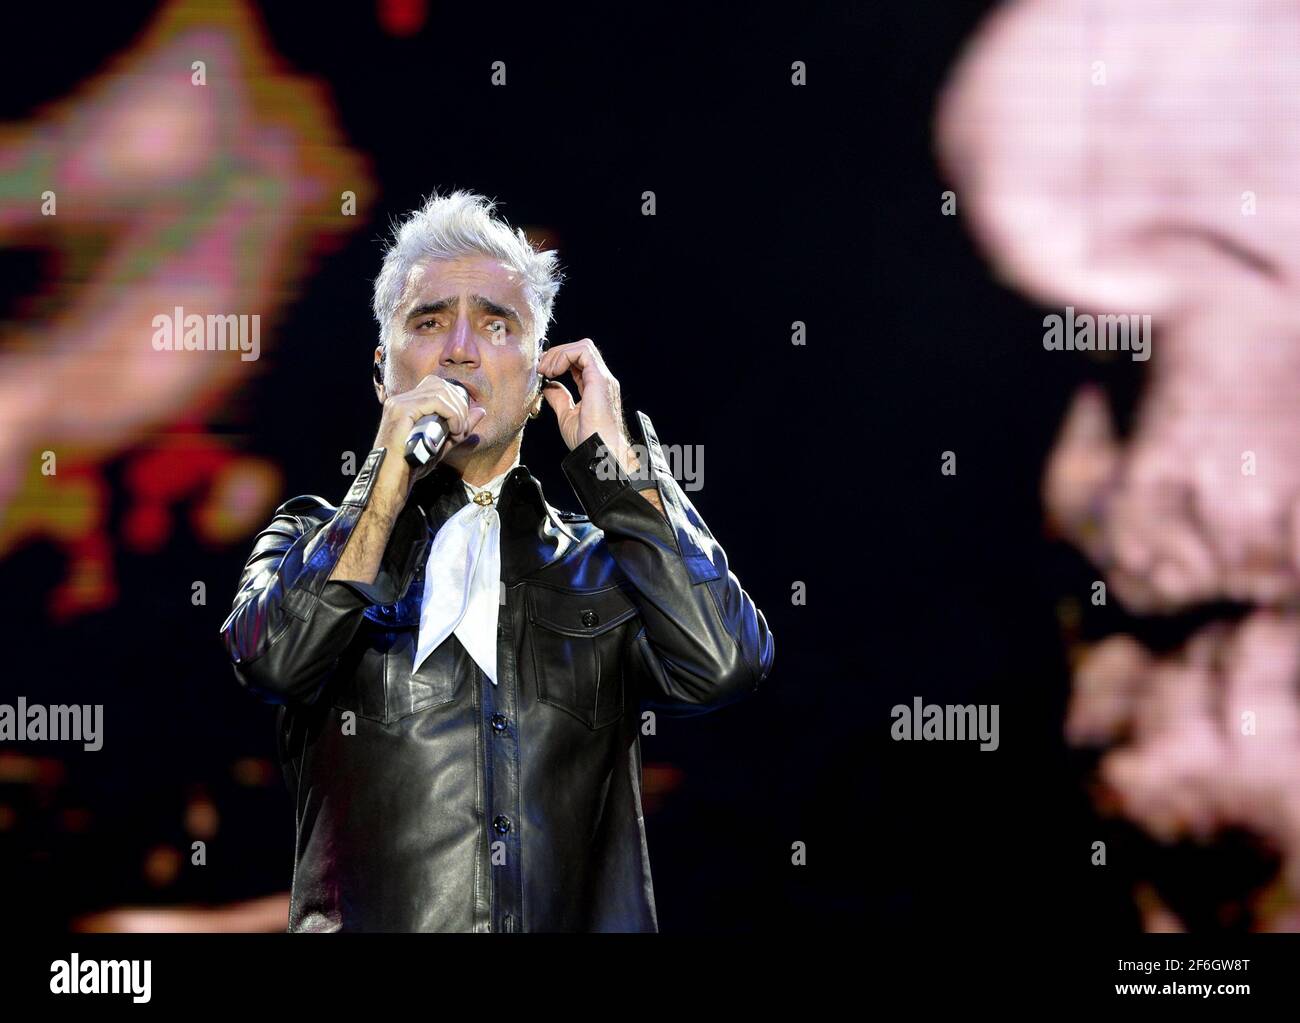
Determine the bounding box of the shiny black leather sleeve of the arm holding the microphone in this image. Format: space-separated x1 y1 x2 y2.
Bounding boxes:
221 447 426 703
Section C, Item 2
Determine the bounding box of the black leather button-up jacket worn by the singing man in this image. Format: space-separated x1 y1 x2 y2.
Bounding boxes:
221 413 774 931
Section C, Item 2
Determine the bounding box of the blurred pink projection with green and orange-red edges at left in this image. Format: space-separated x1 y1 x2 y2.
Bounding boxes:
0 1 373 620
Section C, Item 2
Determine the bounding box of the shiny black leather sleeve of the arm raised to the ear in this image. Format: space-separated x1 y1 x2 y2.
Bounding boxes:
562 412 775 716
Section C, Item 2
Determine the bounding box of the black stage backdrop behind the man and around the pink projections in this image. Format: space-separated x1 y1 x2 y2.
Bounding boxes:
0 3 1206 935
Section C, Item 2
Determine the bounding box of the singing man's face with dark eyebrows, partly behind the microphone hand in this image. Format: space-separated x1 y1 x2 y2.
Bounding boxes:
377 256 538 468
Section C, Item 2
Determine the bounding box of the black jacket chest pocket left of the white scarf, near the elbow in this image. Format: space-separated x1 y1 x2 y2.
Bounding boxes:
334 603 456 724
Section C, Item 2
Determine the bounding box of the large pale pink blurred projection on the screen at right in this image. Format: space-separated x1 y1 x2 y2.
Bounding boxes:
936 0 1300 931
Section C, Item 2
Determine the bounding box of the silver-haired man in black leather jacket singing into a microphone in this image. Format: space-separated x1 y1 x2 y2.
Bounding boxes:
221 191 774 931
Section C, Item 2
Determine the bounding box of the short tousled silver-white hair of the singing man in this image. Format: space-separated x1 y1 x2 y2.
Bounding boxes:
371 190 564 348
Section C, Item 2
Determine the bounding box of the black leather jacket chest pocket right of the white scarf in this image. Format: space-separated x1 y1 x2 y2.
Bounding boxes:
525 586 637 729
